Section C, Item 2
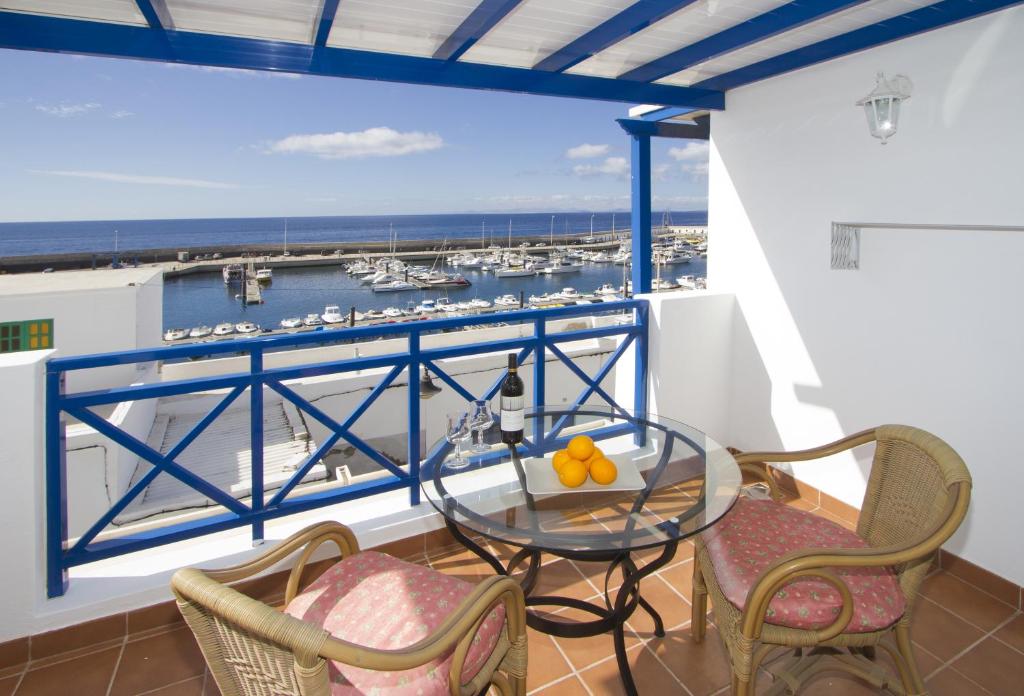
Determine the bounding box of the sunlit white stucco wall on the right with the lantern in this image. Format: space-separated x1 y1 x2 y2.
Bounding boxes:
709 8 1024 583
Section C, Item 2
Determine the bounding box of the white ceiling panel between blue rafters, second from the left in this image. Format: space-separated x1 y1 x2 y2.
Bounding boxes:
167 0 319 43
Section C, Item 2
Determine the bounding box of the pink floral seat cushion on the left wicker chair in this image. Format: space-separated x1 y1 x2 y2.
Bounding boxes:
285 551 505 696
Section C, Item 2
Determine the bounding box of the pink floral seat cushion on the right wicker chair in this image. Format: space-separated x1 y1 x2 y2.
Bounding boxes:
703 497 906 634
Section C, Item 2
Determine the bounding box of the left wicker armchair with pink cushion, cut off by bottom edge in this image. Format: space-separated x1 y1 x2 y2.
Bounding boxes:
172 522 526 696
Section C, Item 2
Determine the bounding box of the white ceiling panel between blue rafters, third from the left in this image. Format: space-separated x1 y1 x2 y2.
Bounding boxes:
327 0 479 57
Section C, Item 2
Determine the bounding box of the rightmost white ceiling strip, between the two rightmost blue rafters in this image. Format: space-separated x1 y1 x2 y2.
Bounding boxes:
658 0 932 86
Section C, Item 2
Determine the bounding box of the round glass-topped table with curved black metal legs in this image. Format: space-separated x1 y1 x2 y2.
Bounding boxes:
420 406 741 694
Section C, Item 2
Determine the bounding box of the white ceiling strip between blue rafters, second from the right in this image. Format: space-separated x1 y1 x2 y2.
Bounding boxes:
566 0 786 78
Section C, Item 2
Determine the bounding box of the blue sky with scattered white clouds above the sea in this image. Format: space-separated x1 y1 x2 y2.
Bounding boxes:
0 50 707 221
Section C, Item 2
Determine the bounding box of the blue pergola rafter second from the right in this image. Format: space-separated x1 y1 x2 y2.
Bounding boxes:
618 0 865 82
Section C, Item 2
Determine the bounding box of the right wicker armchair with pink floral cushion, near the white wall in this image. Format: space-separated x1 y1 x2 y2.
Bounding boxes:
692 426 971 696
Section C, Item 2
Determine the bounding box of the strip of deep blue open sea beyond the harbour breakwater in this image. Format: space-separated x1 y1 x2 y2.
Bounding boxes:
0 211 708 257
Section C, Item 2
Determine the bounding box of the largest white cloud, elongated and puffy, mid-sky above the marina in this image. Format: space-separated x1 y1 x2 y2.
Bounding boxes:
266 126 444 160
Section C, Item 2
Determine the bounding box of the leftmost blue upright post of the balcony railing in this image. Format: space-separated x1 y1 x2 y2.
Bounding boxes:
46 366 68 598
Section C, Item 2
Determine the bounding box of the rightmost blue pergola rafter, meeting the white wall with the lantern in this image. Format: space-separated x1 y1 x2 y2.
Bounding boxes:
693 0 1024 90
